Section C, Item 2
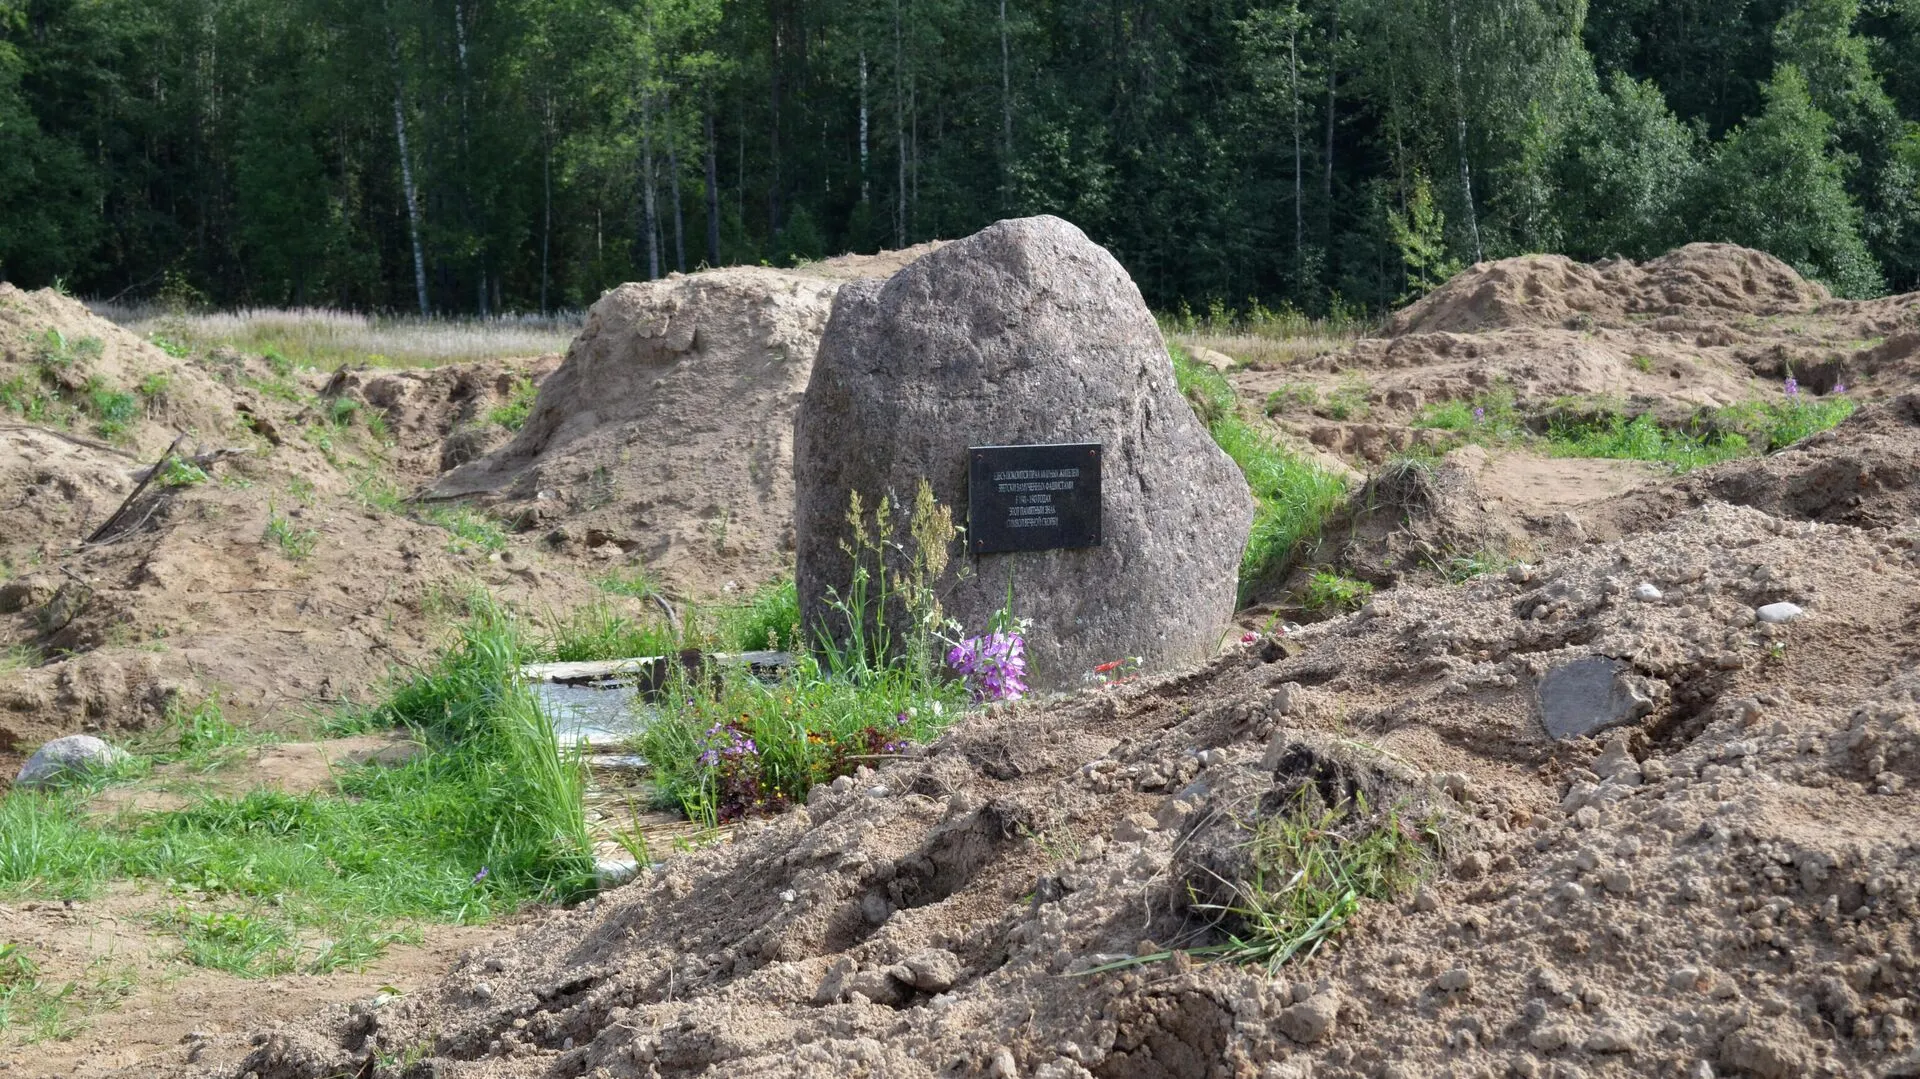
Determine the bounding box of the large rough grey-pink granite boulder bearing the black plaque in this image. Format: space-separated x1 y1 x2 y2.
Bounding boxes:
795 217 1252 685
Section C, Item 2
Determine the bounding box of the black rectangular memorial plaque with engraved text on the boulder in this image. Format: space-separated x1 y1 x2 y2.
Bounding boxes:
966 442 1100 555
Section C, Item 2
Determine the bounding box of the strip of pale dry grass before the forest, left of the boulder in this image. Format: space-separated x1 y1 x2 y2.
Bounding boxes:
92 303 582 368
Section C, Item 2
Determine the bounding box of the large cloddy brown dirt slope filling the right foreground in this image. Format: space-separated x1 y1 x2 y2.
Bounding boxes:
221 505 1920 1079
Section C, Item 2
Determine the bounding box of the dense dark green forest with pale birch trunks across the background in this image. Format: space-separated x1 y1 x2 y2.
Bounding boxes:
0 0 1920 313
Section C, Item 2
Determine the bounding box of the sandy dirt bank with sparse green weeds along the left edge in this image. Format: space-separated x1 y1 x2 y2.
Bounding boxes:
0 286 597 767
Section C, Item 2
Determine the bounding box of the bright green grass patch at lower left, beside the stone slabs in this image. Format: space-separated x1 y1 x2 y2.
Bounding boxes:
0 603 593 975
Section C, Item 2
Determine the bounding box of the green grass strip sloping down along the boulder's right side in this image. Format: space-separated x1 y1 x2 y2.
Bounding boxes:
1167 348 1346 603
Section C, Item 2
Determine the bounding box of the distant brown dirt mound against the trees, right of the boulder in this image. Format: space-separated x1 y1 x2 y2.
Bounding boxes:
1388 244 1832 336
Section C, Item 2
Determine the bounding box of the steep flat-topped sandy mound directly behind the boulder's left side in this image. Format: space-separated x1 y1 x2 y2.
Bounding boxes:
426 244 933 597
